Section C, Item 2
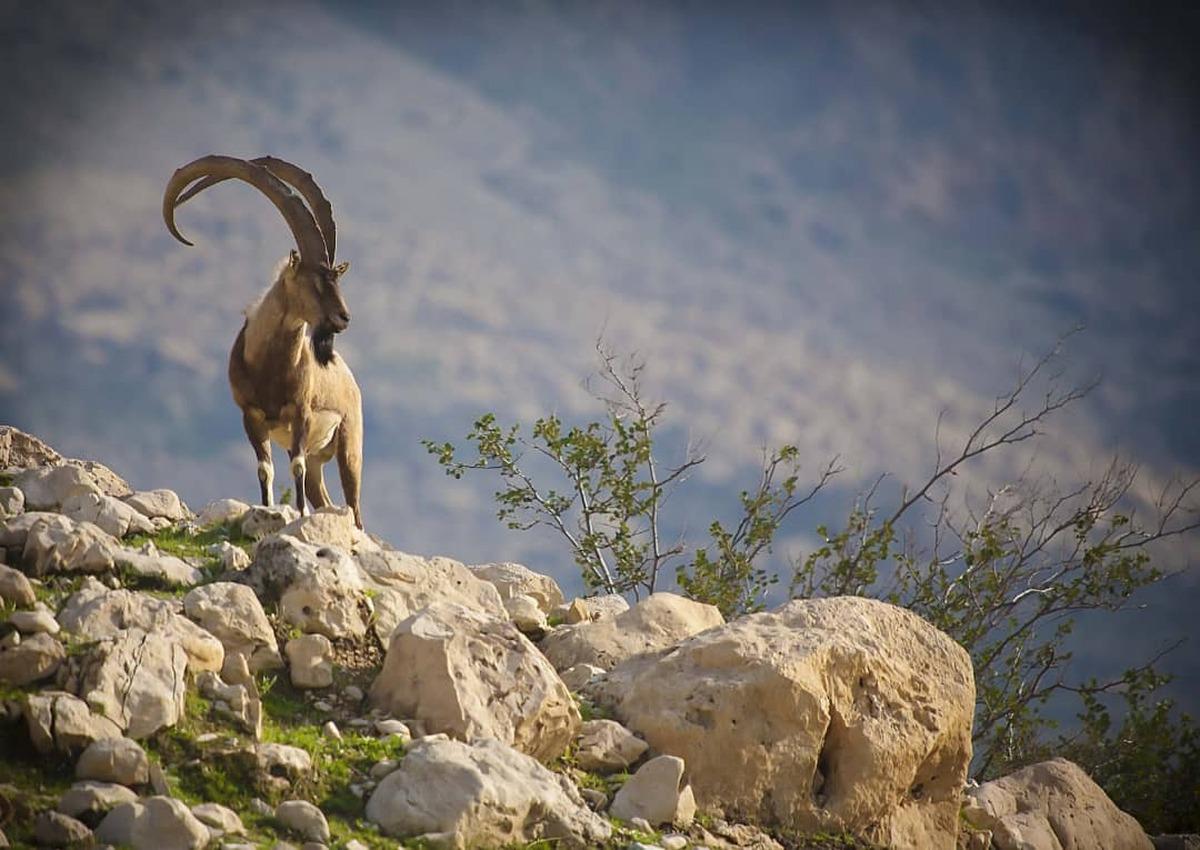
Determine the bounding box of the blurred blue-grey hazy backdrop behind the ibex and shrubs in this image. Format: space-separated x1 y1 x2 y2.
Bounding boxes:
0 2 1200 710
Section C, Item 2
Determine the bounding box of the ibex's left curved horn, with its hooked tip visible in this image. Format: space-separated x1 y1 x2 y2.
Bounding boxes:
162 155 328 267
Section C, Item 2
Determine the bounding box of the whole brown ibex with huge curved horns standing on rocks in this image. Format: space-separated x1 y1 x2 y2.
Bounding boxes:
162 156 362 528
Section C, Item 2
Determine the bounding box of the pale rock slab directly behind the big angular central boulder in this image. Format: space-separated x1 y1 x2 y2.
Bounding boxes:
358 550 508 646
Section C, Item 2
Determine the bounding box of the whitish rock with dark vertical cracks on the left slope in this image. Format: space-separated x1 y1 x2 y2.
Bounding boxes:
79 629 187 738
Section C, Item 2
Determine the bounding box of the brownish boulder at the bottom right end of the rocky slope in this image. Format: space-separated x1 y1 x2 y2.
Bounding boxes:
962 759 1154 850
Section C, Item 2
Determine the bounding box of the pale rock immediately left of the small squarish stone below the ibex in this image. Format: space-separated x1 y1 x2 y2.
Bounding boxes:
184 581 282 672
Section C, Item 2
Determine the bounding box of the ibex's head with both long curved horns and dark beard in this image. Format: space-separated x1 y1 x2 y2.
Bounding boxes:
162 156 350 364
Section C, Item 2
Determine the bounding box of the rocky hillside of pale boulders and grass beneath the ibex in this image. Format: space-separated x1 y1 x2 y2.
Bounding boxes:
0 427 1166 850
